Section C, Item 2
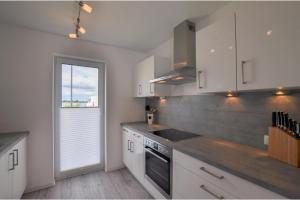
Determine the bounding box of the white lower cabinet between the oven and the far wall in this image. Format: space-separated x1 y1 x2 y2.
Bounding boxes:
123 128 145 183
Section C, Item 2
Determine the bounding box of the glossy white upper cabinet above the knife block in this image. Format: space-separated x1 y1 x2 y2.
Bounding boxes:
236 2 300 90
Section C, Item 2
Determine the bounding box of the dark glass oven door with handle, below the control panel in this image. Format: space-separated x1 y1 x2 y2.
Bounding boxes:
145 146 170 197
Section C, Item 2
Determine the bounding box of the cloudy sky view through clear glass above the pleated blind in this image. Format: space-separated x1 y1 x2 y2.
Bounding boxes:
62 64 98 107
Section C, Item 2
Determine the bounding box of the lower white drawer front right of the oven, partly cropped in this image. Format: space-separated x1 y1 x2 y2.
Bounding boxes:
173 163 236 199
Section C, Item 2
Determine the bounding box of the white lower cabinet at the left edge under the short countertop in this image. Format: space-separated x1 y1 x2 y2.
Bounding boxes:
0 138 27 199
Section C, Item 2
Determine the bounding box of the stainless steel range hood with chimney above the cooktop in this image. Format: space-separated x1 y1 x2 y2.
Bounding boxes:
150 20 196 85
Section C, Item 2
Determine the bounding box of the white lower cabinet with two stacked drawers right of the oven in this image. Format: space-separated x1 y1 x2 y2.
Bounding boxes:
173 150 284 199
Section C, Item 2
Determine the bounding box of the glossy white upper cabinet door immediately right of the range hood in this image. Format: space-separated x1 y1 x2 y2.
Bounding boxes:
196 13 236 92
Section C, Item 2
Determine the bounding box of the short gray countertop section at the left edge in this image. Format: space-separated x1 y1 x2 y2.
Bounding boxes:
0 131 29 157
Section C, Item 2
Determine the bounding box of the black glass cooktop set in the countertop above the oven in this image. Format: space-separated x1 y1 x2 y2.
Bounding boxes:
153 129 200 142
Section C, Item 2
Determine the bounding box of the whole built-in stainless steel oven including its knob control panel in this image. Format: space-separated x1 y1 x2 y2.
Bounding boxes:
144 138 171 198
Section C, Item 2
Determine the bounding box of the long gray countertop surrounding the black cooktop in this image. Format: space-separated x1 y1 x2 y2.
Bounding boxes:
121 122 300 199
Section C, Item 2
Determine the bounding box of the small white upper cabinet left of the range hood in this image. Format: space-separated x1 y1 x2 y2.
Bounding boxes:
134 56 171 97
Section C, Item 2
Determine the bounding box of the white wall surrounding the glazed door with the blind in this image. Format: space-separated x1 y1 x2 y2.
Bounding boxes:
0 24 145 190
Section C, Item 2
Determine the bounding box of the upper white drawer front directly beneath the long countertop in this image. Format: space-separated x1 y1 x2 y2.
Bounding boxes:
173 150 284 199
